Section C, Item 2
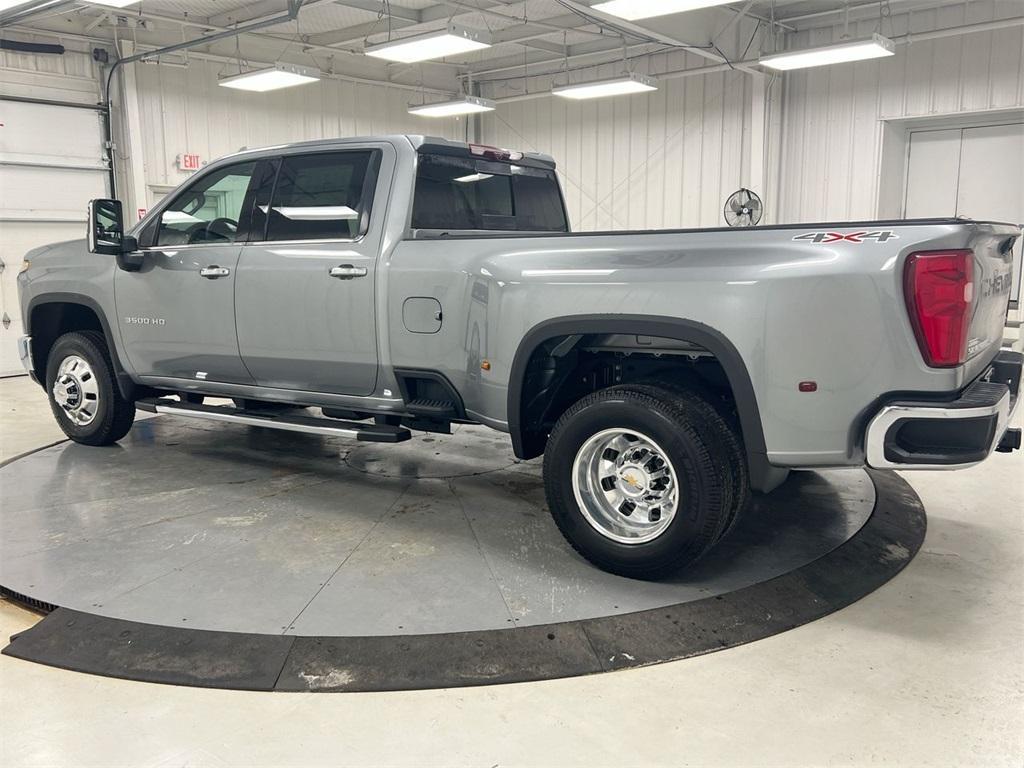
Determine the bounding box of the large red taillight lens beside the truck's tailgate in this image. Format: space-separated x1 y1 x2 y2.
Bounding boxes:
903 251 974 368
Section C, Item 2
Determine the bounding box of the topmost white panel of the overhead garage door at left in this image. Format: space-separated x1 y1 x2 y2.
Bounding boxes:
0 100 103 167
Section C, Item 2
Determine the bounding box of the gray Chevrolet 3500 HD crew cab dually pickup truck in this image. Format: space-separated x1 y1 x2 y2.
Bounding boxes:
18 136 1021 578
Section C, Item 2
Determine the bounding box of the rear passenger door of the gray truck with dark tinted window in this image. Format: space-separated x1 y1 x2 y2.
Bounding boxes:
234 144 394 395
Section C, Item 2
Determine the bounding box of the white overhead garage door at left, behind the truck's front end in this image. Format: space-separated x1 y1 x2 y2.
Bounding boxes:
0 98 108 376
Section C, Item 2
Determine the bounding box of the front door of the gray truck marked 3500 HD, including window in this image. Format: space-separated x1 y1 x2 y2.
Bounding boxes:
115 160 265 383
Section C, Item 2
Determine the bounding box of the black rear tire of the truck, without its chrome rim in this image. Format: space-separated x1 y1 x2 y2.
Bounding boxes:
544 385 733 580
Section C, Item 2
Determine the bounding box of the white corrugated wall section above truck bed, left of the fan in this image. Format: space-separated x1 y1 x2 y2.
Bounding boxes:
481 61 751 230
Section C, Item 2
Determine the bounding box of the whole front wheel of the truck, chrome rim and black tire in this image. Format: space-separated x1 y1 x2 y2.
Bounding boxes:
46 331 135 445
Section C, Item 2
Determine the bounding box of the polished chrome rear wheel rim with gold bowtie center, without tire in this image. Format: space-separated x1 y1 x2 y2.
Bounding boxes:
572 428 679 544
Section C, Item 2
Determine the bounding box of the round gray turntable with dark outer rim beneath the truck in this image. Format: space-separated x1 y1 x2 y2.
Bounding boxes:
0 417 924 690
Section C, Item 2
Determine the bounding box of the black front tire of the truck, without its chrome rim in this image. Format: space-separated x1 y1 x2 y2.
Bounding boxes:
46 331 135 445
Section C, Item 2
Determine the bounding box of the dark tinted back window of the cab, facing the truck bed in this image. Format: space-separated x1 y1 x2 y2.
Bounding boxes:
412 153 568 232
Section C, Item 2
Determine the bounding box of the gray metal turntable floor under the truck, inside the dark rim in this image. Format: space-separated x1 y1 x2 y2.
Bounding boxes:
0 417 874 636
